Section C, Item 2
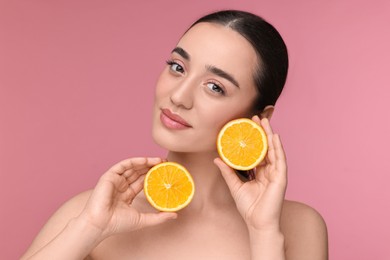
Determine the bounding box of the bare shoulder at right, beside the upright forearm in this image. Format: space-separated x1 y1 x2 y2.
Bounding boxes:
281 200 328 259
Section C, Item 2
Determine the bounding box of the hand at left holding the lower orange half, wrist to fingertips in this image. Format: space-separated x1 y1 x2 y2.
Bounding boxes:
79 158 177 238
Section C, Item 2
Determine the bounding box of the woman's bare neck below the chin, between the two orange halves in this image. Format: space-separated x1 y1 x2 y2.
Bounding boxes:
167 152 235 213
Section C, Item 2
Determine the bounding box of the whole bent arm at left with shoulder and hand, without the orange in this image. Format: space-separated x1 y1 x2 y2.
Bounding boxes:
22 158 177 260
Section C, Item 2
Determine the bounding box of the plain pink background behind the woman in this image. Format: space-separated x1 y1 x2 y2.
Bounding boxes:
0 0 390 260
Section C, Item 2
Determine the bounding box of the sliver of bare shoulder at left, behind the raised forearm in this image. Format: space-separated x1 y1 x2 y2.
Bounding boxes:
25 190 92 255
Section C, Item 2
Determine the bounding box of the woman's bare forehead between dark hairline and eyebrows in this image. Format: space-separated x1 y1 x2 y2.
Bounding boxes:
175 23 258 90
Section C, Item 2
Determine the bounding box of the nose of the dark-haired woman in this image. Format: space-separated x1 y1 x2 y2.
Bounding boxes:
171 79 196 109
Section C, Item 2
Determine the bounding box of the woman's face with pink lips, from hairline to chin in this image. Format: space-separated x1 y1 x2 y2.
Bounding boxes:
152 23 257 152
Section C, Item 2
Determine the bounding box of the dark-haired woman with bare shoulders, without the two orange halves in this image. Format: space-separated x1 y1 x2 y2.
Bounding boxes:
22 11 327 260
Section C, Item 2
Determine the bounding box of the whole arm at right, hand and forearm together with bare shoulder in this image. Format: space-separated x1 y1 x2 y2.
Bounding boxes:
215 116 327 260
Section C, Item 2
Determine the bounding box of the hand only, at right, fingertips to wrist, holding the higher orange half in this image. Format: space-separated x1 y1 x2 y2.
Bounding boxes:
214 116 287 231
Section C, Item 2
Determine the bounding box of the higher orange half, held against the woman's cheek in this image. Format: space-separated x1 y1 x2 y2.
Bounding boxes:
217 118 268 171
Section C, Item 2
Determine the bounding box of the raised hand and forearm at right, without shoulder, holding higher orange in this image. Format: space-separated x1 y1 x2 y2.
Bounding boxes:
215 116 287 260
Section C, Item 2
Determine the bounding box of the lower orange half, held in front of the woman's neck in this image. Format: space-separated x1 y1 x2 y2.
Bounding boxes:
144 162 195 212
